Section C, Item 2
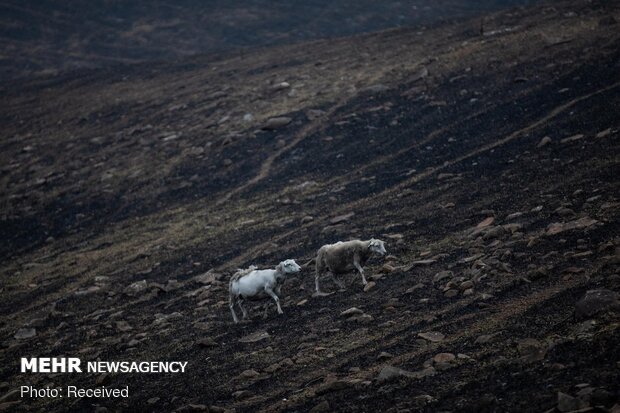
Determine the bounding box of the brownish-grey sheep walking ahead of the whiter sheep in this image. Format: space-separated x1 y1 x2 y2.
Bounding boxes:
314 238 386 296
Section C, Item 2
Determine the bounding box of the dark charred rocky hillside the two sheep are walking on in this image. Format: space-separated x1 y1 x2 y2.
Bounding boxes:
0 1 620 412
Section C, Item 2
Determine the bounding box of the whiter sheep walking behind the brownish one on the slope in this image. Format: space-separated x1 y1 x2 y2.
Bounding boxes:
229 260 301 323
